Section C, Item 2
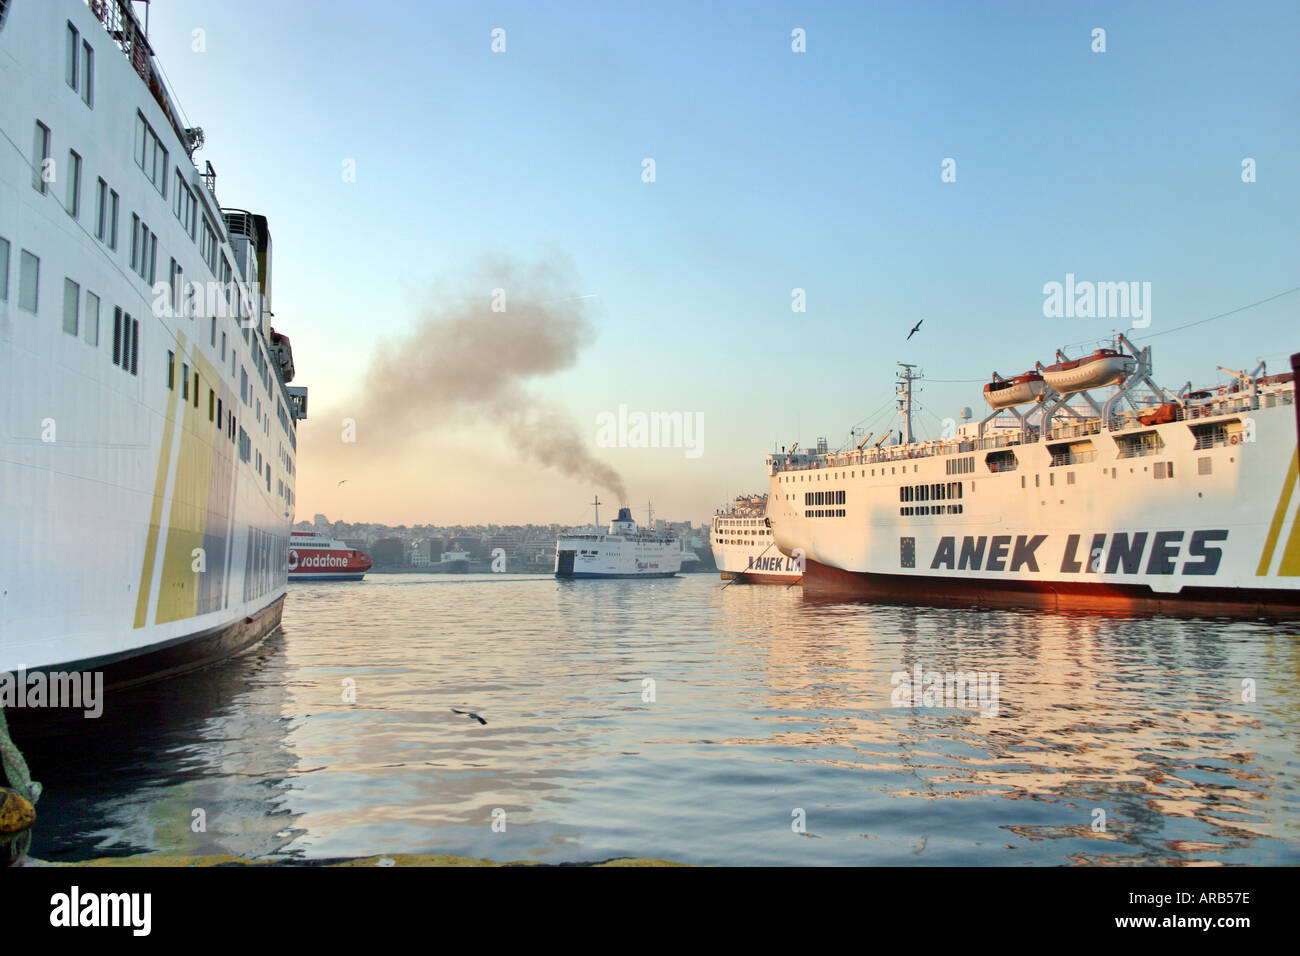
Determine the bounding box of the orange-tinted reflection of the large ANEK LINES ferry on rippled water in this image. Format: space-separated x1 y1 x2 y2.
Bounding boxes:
728 600 1296 862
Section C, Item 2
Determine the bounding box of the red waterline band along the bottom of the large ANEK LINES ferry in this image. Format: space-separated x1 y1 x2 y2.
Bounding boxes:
803 561 1300 618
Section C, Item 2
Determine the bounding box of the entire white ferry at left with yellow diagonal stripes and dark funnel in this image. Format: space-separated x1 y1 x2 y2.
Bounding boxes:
0 0 306 683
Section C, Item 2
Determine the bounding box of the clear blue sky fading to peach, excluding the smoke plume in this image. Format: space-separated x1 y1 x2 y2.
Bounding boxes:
151 0 1300 523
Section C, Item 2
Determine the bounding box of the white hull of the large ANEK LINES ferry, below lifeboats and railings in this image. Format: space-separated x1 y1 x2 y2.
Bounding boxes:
767 377 1300 617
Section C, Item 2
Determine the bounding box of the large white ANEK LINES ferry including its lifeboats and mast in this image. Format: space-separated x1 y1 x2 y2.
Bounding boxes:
767 336 1300 615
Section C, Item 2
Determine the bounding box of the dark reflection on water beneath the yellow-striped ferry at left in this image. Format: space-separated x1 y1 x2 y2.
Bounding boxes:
14 633 302 860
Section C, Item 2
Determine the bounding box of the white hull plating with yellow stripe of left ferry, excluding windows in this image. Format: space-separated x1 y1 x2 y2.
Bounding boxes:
0 0 293 685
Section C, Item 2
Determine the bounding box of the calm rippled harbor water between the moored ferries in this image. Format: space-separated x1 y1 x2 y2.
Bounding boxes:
20 575 1300 865
